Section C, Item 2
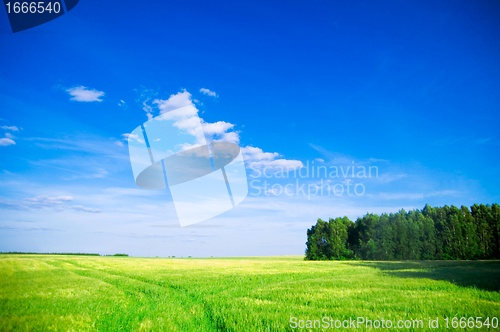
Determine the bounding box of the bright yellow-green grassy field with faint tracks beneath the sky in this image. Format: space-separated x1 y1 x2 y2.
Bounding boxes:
0 255 500 331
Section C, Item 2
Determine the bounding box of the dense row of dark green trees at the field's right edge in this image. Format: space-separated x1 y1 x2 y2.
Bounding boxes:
305 204 500 260
